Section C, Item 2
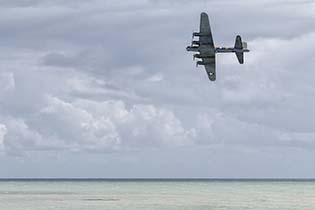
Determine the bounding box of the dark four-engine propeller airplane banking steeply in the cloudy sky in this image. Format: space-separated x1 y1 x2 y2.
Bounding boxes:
186 12 249 81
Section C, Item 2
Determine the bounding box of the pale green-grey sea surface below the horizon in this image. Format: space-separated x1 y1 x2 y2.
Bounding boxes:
0 180 315 210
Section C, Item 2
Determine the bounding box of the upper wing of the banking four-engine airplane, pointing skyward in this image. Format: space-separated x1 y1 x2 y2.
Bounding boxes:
199 12 214 48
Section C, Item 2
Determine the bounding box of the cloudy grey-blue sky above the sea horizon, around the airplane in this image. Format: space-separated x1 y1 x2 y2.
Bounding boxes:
0 0 315 178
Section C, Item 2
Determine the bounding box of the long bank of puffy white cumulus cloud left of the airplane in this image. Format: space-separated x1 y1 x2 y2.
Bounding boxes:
4 96 194 154
